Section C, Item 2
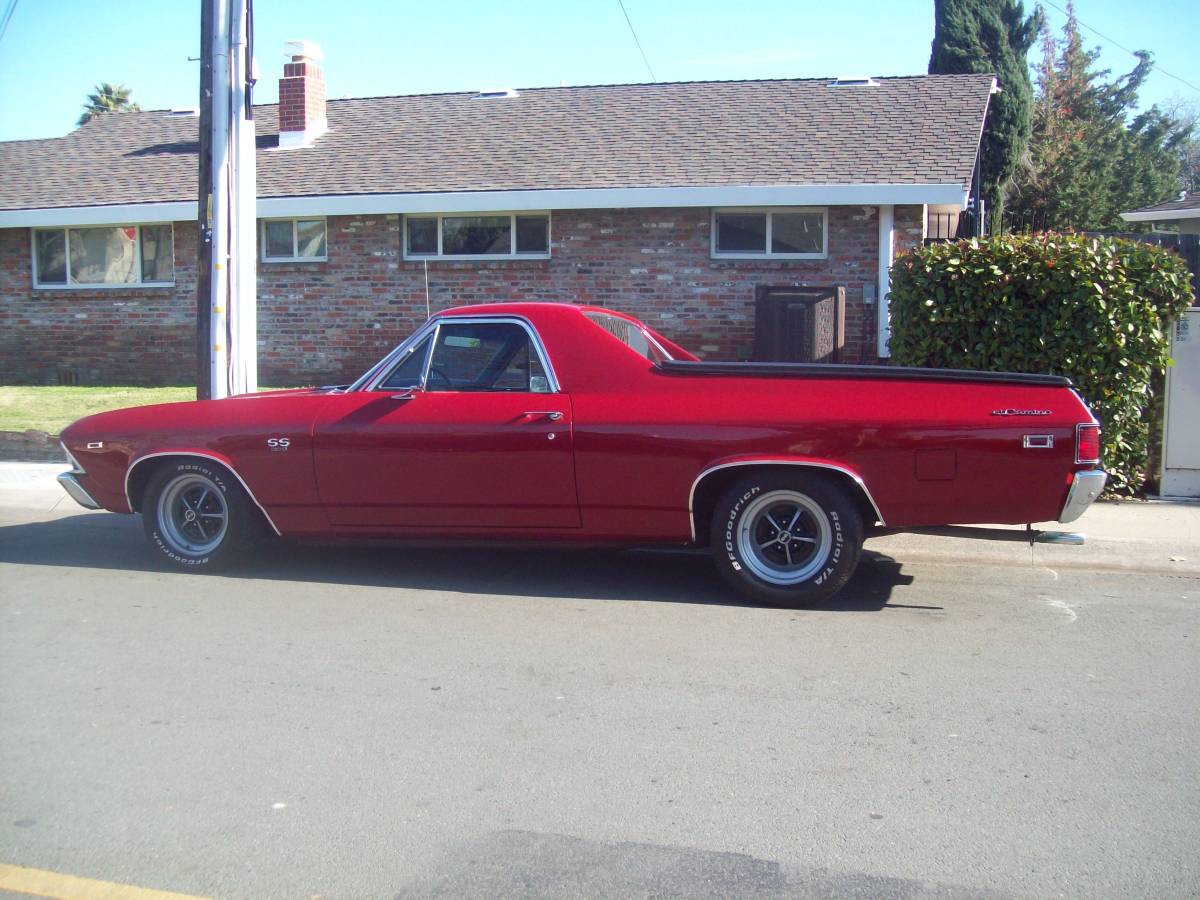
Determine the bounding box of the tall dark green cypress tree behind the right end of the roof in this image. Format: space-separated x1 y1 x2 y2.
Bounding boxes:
929 0 1043 230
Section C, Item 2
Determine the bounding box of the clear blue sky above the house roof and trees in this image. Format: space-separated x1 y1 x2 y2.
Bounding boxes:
0 0 1200 140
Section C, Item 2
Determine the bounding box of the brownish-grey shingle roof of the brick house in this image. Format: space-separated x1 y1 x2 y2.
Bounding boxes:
0 74 991 209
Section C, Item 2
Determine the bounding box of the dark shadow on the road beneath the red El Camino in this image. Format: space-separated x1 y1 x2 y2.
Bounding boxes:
0 514 921 612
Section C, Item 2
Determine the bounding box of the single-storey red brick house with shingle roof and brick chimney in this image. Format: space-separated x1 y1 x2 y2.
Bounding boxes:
0 50 995 384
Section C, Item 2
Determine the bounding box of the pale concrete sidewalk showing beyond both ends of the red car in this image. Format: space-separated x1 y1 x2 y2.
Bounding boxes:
0 462 1200 577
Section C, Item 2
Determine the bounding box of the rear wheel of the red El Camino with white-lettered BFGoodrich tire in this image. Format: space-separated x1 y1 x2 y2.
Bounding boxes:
710 470 863 606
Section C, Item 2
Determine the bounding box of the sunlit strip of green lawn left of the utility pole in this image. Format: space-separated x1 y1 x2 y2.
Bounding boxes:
0 385 196 434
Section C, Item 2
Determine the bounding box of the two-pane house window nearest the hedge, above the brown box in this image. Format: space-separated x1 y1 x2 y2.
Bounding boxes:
712 208 828 259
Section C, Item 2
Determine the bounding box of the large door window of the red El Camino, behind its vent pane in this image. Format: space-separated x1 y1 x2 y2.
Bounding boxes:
425 322 550 394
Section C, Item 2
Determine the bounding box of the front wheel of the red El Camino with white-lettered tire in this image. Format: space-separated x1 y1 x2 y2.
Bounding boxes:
142 458 257 570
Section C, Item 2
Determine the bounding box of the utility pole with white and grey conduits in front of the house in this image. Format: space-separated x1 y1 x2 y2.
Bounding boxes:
197 0 258 398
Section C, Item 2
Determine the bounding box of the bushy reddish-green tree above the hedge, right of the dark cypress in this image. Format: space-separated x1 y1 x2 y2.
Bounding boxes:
1010 4 1189 230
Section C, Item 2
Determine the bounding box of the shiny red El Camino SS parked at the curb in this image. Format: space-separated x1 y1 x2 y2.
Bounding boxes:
60 304 1105 605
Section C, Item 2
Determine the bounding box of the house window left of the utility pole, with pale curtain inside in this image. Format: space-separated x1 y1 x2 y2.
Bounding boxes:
34 223 175 288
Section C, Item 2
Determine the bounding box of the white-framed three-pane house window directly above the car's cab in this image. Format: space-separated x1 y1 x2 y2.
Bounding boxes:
404 212 550 259
